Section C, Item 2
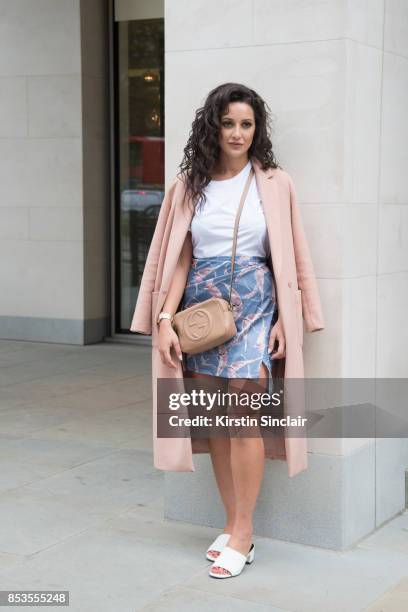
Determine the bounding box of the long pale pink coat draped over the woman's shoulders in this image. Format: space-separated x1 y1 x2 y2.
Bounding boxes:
130 157 324 477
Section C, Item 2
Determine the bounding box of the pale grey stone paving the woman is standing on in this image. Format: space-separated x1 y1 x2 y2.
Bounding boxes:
0 340 408 612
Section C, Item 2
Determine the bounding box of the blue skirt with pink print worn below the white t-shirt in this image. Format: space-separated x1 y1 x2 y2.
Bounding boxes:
181 255 278 378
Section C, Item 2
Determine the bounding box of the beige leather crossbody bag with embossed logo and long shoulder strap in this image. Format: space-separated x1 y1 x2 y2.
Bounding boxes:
173 166 254 355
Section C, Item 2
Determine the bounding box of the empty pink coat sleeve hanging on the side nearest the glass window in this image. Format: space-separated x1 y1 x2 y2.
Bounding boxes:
129 177 178 335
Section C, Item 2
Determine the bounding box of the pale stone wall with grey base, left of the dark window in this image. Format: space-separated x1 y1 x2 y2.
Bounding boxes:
0 0 109 344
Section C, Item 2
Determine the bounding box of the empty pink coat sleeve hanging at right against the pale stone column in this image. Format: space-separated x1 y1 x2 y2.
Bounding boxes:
288 174 325 332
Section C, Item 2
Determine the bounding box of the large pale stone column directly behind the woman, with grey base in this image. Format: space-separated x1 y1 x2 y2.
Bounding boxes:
162 0 408 549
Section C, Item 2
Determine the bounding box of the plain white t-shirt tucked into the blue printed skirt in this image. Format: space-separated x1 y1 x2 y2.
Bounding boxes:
189 160 270 259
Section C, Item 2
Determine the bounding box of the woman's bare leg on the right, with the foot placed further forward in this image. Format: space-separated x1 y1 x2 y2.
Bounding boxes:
212 363 268 573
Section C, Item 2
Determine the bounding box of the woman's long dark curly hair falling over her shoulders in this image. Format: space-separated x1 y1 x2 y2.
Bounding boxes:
179 83 281 213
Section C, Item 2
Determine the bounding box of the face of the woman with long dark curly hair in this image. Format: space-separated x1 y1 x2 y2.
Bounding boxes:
218 102 255 159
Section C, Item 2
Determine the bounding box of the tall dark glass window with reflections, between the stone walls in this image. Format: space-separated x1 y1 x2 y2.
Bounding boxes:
115 18 164 333
